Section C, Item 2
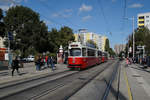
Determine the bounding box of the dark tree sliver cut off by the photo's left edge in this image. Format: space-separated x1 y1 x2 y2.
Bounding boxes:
0 8 5 37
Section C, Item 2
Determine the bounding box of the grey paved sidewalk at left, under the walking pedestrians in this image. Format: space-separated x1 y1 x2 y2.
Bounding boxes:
0 63 68 84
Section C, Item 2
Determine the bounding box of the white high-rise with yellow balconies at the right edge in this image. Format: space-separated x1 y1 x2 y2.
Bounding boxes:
137 12 150 30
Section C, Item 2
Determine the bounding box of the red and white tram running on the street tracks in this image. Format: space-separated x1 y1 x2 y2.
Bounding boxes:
68 42 108 70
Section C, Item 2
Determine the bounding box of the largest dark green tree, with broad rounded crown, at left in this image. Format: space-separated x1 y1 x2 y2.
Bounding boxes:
4 6 48 56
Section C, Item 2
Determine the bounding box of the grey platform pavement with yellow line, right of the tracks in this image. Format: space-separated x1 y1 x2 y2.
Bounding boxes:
119 61 150 100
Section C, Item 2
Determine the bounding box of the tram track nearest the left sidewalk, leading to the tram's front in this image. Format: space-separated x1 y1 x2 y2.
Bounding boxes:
0 70 77 99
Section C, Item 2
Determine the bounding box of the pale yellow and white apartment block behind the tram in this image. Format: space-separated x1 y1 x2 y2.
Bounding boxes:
74 31 102 50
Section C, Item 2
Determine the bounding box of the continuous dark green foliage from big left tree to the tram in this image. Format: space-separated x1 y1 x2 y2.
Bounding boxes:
0 6 74 57
